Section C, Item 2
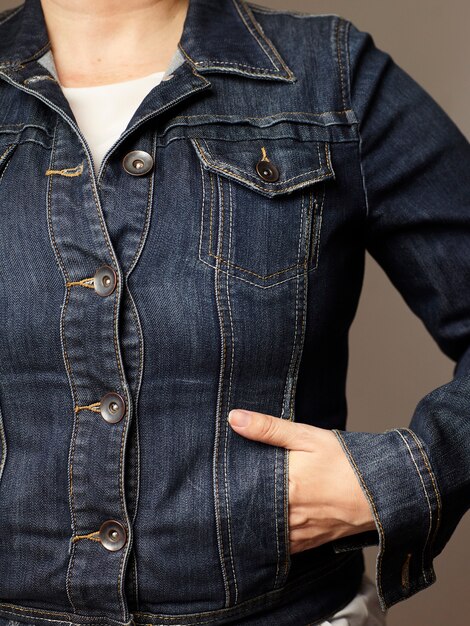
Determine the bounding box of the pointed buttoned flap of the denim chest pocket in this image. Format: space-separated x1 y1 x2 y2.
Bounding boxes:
191 137 335 197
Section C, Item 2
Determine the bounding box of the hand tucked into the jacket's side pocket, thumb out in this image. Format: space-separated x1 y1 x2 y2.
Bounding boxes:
229 409 376 554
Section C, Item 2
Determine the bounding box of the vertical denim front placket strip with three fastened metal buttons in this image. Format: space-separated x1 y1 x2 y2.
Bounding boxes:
48 123 132 621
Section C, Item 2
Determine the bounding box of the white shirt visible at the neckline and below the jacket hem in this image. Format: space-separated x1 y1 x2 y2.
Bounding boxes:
57 72 386 626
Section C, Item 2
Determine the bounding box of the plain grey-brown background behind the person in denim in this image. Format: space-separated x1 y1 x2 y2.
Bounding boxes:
0 0 470 626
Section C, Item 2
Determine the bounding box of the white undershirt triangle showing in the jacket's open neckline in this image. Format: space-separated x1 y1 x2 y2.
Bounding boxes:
61 72 165 173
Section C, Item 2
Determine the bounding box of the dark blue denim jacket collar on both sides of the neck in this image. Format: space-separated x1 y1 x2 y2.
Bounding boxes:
0 0 296 82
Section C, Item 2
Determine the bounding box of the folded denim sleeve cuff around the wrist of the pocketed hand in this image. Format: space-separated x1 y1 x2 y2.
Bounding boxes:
332 428 441 611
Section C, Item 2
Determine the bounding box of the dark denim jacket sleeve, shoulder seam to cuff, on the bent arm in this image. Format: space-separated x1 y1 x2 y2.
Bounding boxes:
333 18 470 611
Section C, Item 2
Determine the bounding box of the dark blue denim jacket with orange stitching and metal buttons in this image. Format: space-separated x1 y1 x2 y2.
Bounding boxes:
0 0 470 626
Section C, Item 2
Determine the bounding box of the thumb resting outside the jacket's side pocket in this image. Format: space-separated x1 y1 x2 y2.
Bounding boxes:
228 409 305 449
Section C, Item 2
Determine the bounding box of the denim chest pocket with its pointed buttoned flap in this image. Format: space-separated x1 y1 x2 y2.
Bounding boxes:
191 137 335 288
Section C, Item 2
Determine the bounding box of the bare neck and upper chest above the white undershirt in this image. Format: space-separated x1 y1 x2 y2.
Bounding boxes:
41 0 189 87
